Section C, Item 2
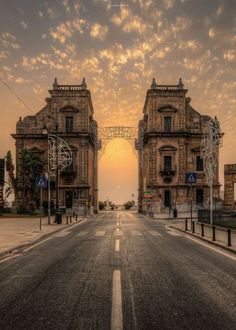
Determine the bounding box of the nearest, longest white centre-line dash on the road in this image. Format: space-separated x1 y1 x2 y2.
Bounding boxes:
111 270 123 330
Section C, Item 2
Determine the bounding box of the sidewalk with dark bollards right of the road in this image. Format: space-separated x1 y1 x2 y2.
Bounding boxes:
170 220 236 253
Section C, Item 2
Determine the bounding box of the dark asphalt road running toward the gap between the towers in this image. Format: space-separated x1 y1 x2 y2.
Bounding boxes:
0 212 236 330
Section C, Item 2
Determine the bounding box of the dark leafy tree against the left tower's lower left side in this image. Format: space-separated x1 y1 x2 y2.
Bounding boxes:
17 149 44 209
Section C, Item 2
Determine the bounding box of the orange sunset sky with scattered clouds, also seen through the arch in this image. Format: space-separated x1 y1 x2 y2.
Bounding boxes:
0 0 236 203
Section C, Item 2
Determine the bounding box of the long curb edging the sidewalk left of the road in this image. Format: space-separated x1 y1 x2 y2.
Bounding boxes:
0 218 87 260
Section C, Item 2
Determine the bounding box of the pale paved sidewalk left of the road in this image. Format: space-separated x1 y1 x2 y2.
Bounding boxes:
0 216 84 257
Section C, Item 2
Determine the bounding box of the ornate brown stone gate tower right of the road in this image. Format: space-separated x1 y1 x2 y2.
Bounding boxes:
137 79 220 212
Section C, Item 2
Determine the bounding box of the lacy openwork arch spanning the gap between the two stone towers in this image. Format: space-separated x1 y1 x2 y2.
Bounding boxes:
98 126 138 159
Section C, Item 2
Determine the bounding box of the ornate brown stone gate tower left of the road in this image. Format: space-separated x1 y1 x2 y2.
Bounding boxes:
12 79 98 211
